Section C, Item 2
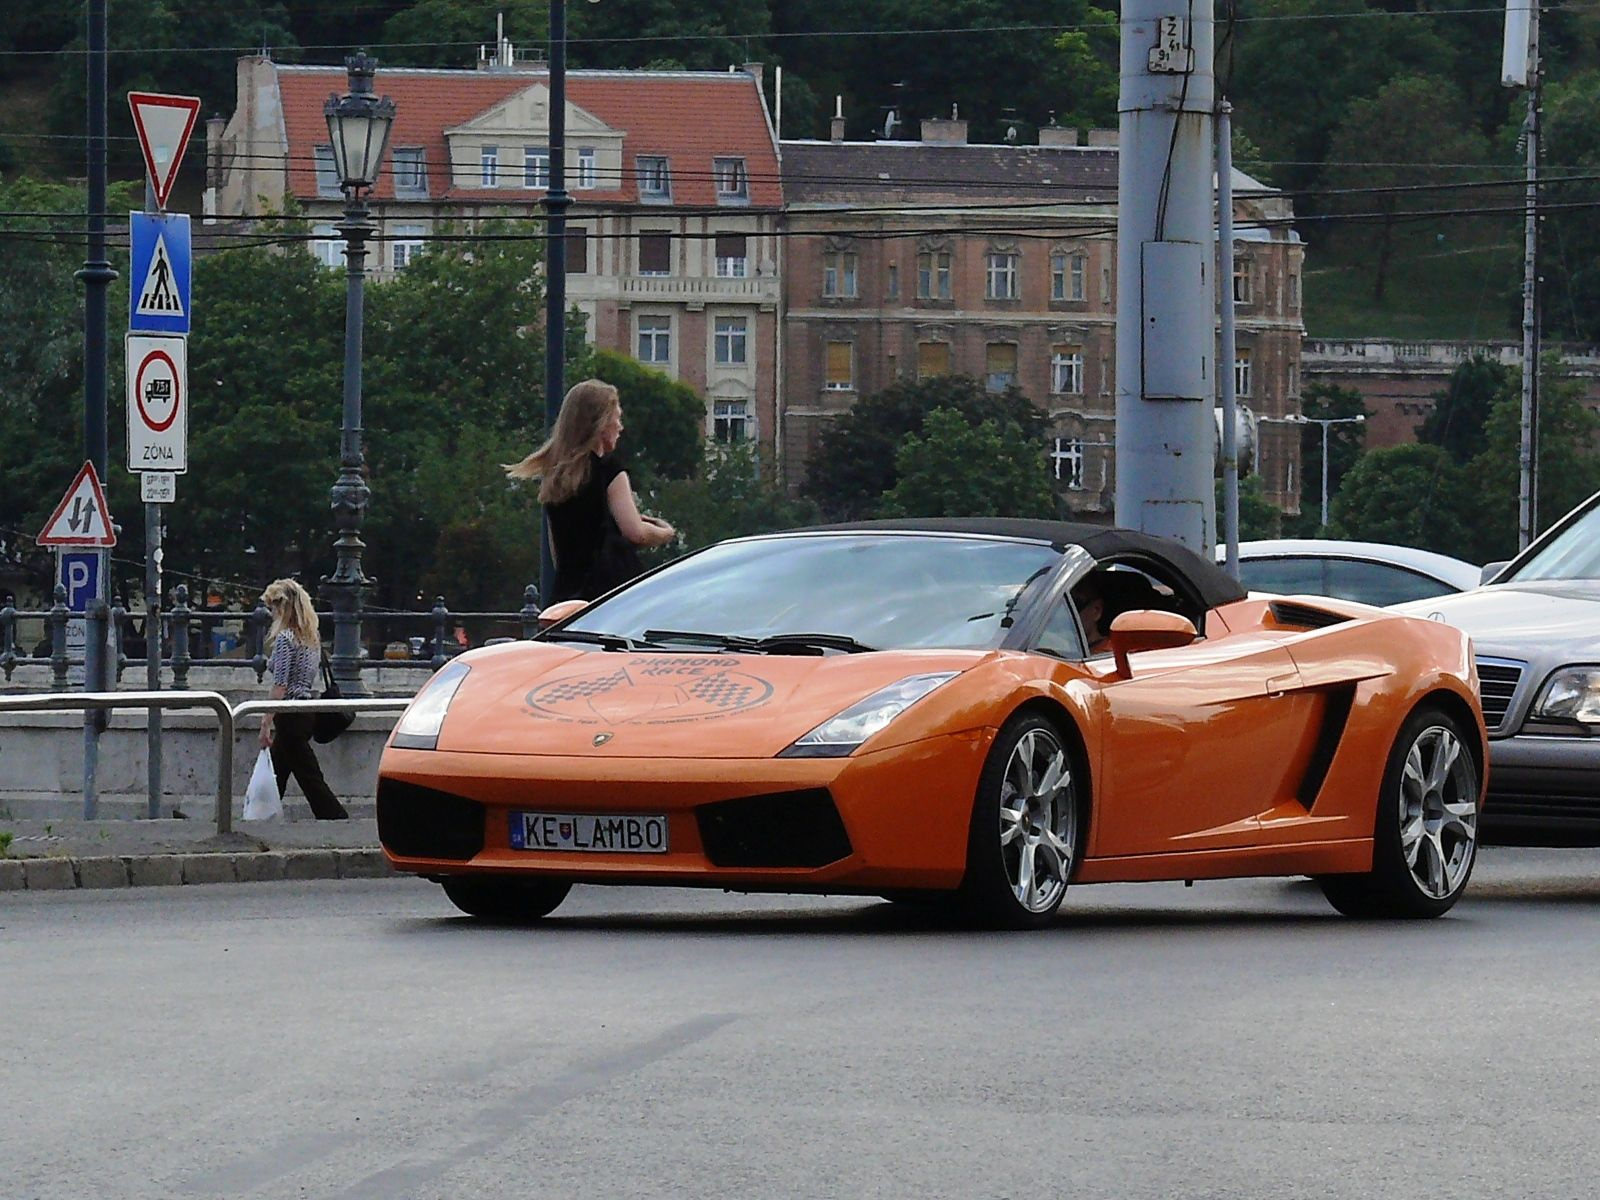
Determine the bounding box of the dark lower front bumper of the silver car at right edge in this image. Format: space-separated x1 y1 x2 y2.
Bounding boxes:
1482 734 1600 846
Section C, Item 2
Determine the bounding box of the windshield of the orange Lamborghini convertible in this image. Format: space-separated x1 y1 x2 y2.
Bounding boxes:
566 533 1061 650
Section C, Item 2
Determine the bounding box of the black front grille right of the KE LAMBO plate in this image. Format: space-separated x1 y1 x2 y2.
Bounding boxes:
694 787 850 867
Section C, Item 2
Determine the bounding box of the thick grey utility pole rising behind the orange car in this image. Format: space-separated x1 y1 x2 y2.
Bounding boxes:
1117 0 1230 554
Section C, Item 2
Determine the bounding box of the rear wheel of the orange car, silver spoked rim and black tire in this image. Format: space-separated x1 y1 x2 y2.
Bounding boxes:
1317 704 1480 918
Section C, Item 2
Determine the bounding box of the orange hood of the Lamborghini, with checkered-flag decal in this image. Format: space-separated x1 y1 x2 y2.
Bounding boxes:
438 642 994 758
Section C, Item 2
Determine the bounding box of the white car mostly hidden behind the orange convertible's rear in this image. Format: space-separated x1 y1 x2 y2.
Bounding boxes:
1216 538 1483 605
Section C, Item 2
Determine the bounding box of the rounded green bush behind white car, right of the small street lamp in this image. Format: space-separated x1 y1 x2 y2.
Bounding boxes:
1328 445 1477 558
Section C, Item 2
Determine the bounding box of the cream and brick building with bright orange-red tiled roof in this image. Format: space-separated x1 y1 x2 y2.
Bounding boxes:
208 45 782 446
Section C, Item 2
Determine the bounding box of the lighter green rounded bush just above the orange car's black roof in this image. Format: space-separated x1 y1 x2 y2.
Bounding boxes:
877 408 1056 517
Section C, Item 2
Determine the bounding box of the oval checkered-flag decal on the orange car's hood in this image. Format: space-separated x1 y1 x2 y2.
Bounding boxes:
523 654 773 723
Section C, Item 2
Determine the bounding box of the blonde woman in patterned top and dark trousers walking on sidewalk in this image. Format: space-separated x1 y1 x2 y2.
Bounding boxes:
261 579 350 821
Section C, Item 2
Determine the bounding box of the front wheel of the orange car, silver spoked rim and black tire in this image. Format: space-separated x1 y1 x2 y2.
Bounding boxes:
960 712 1088 930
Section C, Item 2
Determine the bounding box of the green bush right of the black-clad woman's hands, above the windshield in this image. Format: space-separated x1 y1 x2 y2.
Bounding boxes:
659 442 816 550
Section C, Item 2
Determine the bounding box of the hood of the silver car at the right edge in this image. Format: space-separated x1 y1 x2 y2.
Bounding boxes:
1390 579 1600 658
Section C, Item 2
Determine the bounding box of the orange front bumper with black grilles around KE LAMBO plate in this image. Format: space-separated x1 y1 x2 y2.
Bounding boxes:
378 730 994 891
